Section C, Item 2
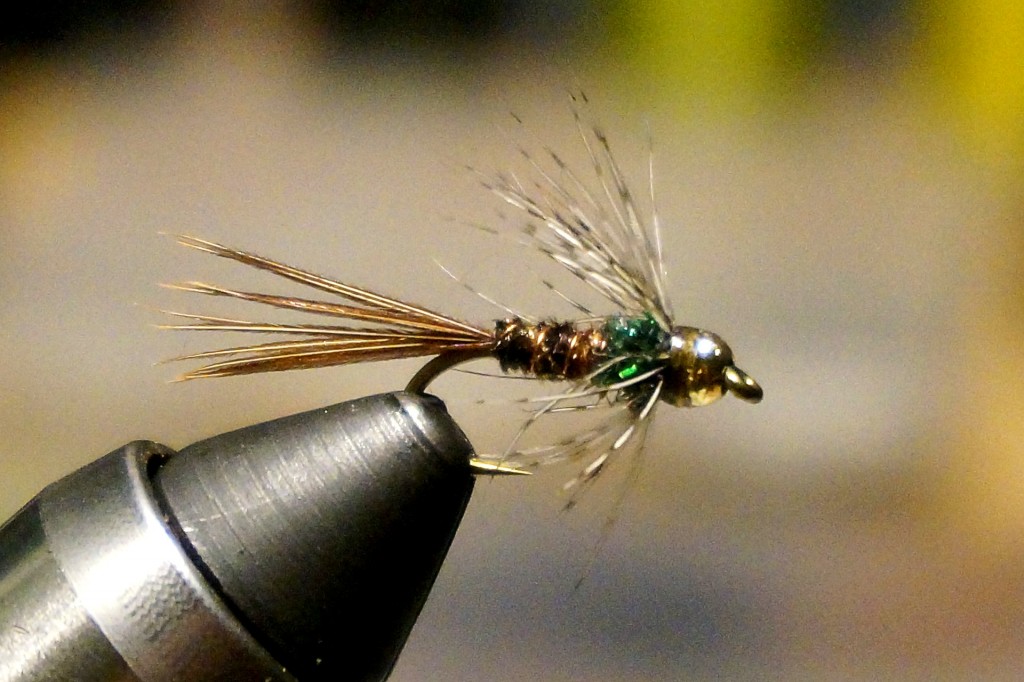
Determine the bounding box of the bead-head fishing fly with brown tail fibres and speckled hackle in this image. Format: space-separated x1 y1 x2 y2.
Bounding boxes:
164 95 762 489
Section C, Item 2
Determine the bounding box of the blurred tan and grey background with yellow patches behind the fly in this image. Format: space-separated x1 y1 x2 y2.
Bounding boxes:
0 0 1024 681
